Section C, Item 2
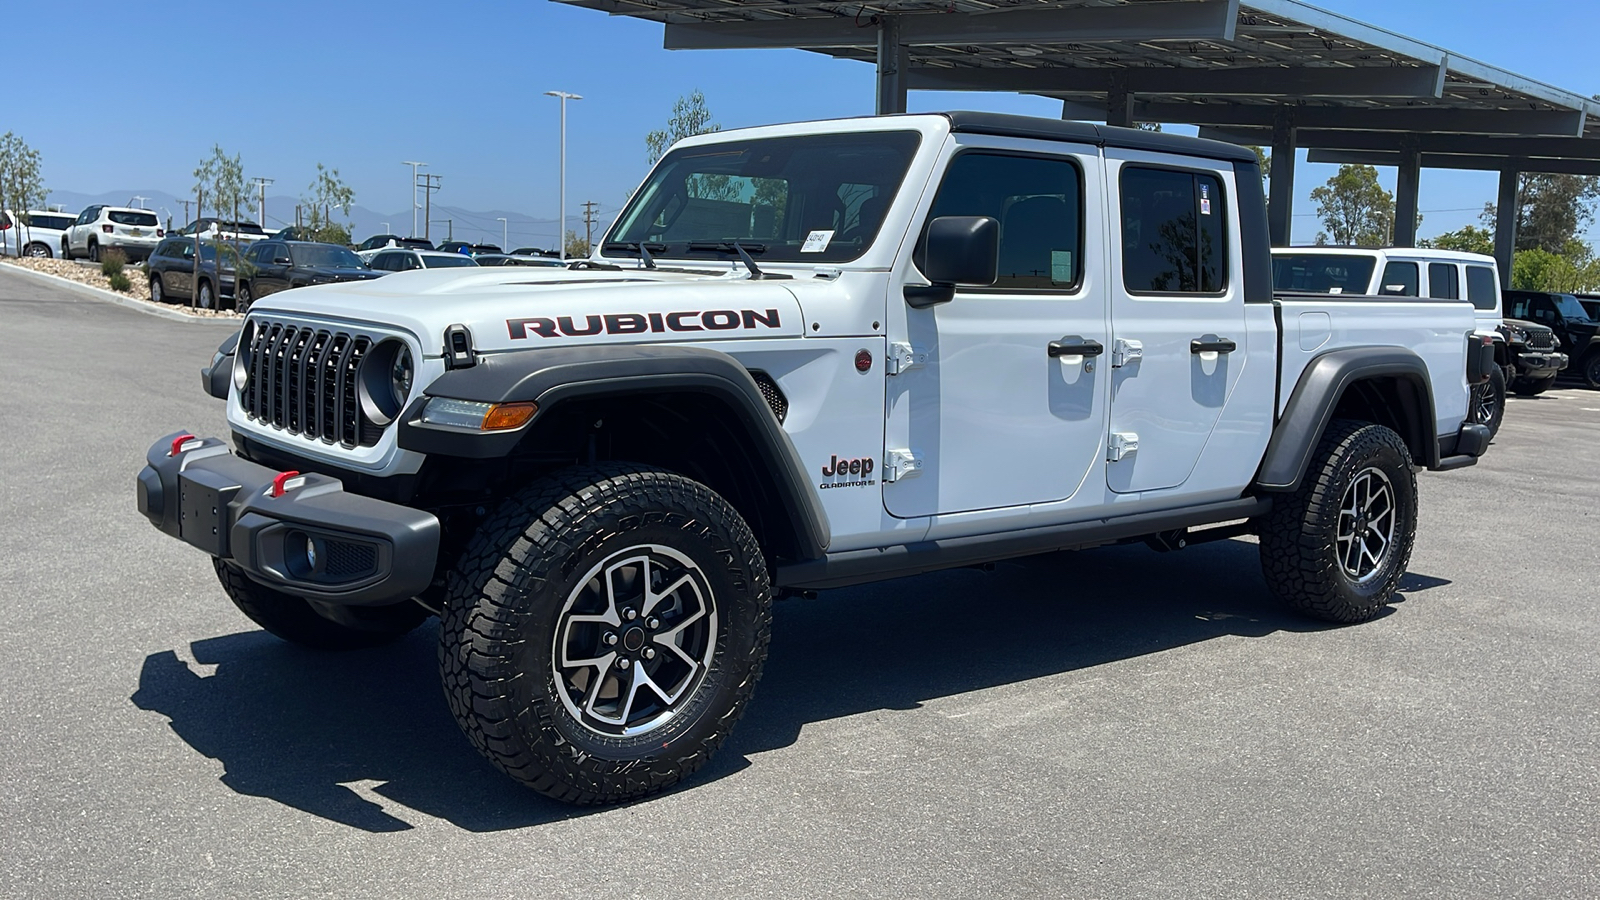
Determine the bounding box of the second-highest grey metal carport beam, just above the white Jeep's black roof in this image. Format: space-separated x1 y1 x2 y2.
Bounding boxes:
910 66 1445 98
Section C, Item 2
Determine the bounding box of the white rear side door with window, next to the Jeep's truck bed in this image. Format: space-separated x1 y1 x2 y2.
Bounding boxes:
1106 151 1245 493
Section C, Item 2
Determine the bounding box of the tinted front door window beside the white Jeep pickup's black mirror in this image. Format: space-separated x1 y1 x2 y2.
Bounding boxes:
921 152 1083 291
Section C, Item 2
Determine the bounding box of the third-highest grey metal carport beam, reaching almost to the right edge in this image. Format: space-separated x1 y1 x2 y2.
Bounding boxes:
1107 98 1584 138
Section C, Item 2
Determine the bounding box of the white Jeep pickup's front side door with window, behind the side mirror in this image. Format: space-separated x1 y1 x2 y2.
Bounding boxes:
883 136 1107 517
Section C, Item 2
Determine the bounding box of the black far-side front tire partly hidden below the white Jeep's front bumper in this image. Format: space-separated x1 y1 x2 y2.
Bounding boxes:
211 557 429 650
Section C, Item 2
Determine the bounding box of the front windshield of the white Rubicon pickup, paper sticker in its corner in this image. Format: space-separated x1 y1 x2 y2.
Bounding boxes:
603 131 922 263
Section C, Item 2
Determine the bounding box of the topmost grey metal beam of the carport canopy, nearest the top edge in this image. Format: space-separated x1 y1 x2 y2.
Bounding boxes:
664 0 1240 50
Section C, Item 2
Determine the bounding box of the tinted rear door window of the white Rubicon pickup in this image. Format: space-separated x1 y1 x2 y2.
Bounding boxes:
1122 167 1227 293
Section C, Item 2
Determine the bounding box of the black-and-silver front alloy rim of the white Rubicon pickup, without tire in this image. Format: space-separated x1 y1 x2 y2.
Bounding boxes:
550 544 720 738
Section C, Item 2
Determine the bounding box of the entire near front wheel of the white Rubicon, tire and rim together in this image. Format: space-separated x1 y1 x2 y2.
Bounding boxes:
438 464 773 804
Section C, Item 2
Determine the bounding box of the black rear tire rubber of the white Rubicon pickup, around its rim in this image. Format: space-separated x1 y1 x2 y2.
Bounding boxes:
1261 420 1416 623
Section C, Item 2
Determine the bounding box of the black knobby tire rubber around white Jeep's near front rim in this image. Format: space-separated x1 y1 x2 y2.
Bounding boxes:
438 464 773 804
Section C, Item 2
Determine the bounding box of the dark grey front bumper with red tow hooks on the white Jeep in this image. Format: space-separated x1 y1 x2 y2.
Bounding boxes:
138 432 440 605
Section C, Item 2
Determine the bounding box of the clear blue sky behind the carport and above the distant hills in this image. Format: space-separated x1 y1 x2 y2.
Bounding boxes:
0 0 1600 243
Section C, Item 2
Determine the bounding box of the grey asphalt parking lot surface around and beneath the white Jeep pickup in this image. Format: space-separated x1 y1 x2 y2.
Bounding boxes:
0 265 1600 898
